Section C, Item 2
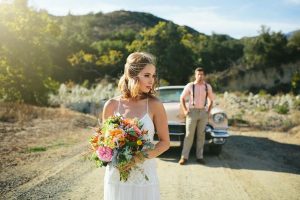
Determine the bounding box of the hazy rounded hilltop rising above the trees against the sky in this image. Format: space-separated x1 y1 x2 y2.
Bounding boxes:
53 10 199 39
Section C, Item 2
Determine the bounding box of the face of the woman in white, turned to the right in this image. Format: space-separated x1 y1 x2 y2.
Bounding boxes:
138 64 156 93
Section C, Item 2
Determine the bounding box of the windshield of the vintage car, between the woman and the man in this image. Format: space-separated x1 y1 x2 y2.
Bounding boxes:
158 88 188 103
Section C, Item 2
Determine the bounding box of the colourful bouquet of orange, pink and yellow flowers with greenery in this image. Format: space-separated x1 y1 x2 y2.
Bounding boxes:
90 116 154 182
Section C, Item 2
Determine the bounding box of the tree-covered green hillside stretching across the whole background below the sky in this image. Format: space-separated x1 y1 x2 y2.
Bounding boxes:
0 0 300 105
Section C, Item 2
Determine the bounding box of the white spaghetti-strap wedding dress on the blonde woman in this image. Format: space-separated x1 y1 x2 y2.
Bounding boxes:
104 99 160 200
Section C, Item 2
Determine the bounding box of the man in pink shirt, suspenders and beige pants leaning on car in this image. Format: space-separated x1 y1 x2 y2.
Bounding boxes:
179 67 214 165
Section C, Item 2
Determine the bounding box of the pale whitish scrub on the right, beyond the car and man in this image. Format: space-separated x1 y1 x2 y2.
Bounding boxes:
215 92 300 130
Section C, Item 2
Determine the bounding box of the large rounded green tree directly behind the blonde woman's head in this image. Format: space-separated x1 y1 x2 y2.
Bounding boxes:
127 22 195 84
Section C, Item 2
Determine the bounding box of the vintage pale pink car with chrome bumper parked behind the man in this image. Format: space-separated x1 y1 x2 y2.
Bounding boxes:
156 86 229 155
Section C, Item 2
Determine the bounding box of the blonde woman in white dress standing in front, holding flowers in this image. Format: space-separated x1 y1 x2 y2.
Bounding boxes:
102 52 170 200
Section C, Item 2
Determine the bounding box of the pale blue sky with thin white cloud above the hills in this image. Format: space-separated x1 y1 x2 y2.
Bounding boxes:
17 0 300 39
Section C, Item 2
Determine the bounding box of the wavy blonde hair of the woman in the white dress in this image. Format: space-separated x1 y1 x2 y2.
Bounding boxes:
118 52 157 98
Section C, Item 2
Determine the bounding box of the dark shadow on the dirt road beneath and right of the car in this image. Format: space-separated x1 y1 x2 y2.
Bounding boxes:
159 135 300 174
